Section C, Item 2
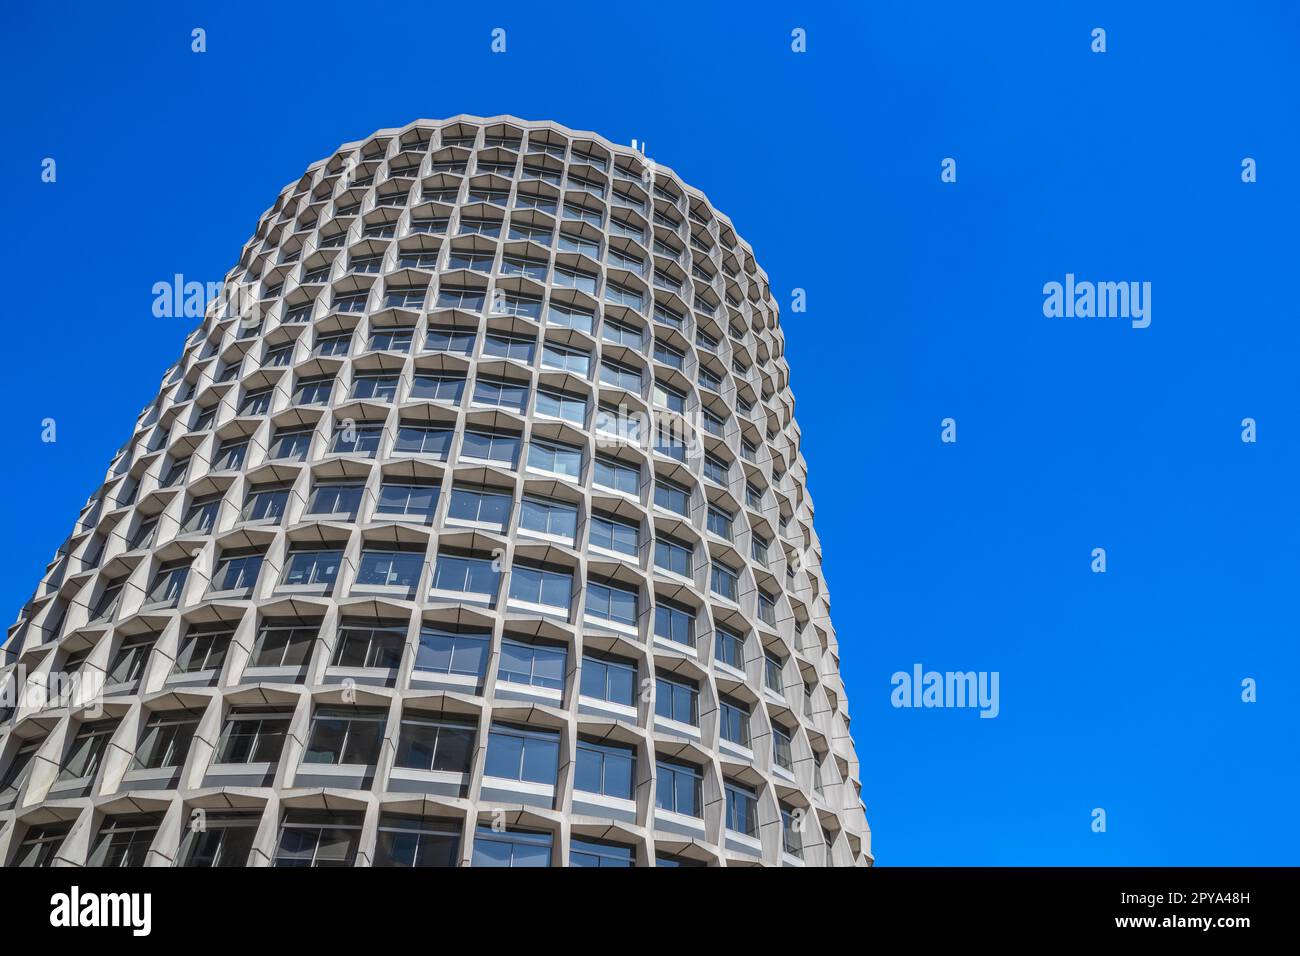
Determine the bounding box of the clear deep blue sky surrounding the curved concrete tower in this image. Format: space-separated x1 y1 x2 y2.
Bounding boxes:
0 1 1300 865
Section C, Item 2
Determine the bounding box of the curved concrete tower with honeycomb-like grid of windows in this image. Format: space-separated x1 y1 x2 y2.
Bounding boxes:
0 117 871 866
